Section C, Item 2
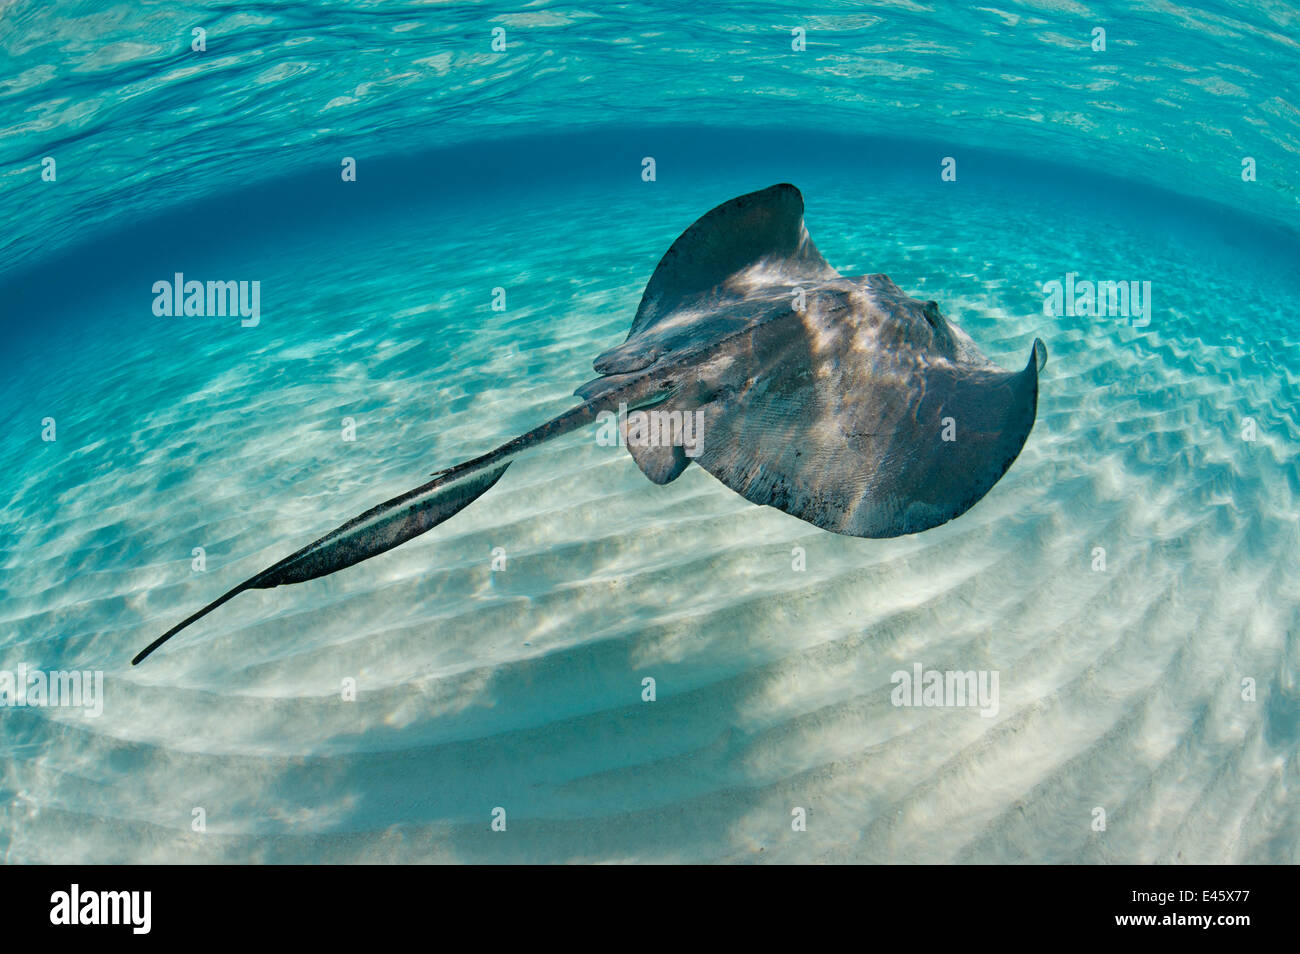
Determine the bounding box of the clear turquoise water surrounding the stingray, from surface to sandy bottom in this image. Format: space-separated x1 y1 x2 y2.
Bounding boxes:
0 3 1300 863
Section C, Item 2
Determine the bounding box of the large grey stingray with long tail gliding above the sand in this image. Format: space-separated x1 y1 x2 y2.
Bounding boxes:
131 183 1047 664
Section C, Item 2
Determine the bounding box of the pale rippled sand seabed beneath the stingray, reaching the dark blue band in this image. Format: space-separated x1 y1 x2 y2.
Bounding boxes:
0 168 1300 863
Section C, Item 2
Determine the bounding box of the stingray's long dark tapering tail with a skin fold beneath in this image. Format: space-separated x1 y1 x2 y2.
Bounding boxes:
131 402 603 665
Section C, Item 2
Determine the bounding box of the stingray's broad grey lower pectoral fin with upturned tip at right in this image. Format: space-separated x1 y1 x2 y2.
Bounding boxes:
670 334 1047 537
